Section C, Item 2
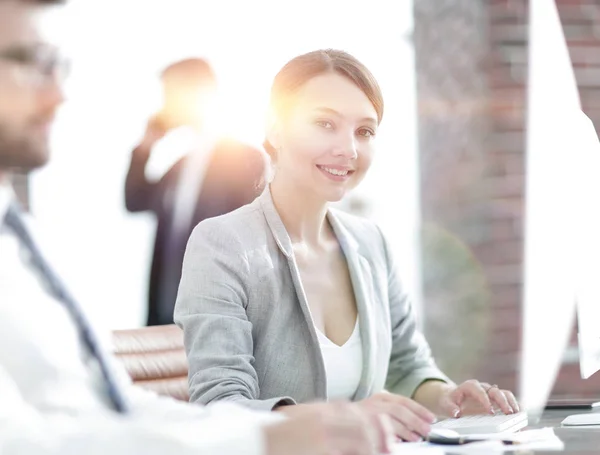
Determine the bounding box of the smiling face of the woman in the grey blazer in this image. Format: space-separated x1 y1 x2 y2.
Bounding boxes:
270 73 378 202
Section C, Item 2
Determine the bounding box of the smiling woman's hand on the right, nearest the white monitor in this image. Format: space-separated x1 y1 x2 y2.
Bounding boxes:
440 379 520 417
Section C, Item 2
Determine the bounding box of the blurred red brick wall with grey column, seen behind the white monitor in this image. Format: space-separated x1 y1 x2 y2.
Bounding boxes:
414 0 600 395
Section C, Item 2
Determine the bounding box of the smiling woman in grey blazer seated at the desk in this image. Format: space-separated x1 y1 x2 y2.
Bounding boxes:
175 50 518 440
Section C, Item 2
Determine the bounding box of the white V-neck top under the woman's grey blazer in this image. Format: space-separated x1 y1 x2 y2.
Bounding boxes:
317 318 363 400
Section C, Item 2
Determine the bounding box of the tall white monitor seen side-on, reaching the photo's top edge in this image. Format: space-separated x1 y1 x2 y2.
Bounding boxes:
519 0 584 423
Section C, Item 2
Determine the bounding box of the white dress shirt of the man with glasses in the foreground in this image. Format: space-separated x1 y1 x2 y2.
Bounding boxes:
0 184 280 455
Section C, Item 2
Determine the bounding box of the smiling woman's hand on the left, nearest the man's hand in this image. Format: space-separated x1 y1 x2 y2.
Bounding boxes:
358 392 435 442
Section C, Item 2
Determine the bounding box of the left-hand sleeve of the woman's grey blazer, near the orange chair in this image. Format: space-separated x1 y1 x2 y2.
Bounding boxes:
175 218 294 410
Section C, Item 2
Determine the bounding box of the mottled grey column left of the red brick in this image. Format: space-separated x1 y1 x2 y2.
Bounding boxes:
414 0 490 380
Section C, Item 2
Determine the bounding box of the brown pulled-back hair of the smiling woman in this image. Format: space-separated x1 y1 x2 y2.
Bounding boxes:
263 49 383 159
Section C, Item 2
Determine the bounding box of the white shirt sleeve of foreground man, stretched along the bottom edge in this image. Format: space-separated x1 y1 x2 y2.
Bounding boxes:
0 367 273 455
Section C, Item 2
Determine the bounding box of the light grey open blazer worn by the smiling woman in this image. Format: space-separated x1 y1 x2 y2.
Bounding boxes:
175 187 449 410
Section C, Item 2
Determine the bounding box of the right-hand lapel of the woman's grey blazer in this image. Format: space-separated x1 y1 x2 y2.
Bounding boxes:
327 210 376 400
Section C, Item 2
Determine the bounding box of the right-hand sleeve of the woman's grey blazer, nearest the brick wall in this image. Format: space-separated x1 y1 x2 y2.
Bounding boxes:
381 228 452 397
